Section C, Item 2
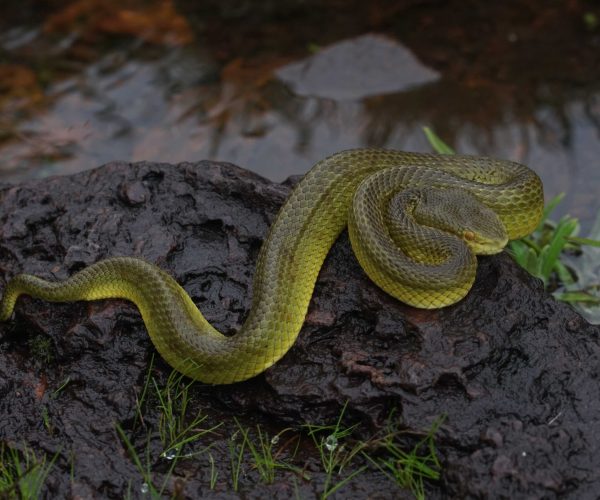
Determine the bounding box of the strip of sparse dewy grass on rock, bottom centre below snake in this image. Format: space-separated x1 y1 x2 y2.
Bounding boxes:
116 368 442 500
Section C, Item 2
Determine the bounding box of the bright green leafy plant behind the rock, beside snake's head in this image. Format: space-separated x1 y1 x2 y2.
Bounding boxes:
423 127 600 305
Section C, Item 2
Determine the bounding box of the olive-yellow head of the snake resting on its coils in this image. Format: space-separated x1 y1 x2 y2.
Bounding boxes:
414 188 508 255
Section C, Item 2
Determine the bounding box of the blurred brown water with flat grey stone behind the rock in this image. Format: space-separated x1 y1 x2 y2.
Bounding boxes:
0 0 600 232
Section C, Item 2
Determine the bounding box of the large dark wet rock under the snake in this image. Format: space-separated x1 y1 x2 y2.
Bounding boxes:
0 162 600 499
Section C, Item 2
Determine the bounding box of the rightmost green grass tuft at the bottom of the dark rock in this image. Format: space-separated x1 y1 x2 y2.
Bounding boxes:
363 416 445 500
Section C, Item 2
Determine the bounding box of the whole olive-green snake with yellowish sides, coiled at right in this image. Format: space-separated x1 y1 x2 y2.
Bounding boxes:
0 149 543 384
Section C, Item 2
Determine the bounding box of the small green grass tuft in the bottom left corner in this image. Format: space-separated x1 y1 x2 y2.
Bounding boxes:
0 443 58 500
